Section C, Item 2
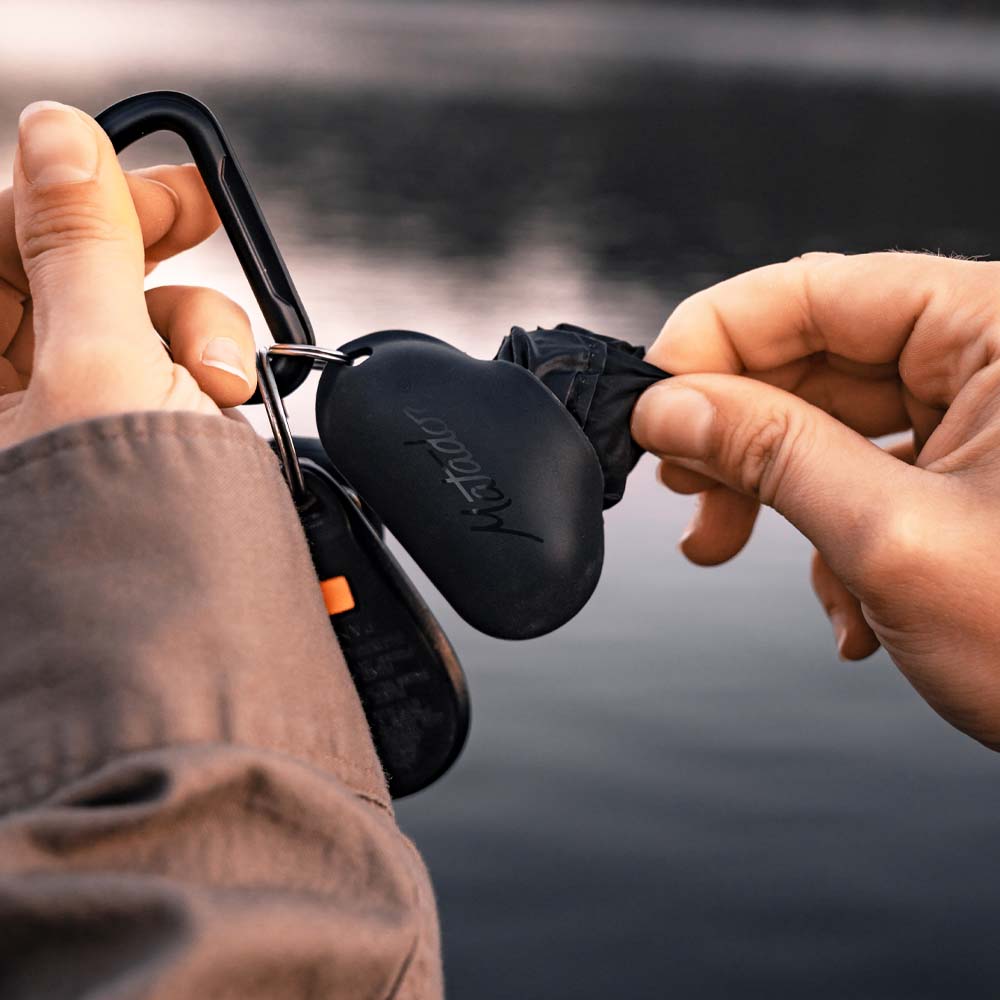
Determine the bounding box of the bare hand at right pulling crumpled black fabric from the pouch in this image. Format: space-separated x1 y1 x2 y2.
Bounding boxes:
632 253 1000 749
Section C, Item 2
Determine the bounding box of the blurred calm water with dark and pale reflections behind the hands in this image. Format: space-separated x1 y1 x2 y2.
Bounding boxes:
0 0 1000 1000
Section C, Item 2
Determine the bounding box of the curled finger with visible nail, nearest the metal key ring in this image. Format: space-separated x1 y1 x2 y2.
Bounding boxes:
146 285 257 408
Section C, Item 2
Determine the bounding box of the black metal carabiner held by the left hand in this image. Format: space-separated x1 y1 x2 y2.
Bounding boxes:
97 90 316 403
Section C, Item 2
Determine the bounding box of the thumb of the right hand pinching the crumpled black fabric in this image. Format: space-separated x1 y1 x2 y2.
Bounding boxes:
632 375 915 577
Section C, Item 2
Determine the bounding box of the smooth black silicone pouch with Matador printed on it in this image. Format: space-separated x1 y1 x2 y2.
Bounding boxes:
316 330 604 639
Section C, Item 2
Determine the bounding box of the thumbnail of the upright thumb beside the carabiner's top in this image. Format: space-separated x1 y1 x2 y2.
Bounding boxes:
18 101 99 186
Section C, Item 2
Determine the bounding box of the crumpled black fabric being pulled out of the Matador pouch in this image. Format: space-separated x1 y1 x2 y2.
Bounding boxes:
495 323 670 509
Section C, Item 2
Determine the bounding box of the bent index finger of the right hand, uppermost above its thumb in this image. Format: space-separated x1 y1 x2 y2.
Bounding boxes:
647 253 1000 407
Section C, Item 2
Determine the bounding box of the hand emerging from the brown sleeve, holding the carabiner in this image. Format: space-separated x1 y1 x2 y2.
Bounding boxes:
0 102 256 447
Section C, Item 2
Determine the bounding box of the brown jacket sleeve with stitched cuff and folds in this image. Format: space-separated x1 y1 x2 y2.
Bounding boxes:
0 413 441 1000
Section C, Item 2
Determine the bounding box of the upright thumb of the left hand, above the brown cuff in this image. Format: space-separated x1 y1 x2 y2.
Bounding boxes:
14 101 160 378
